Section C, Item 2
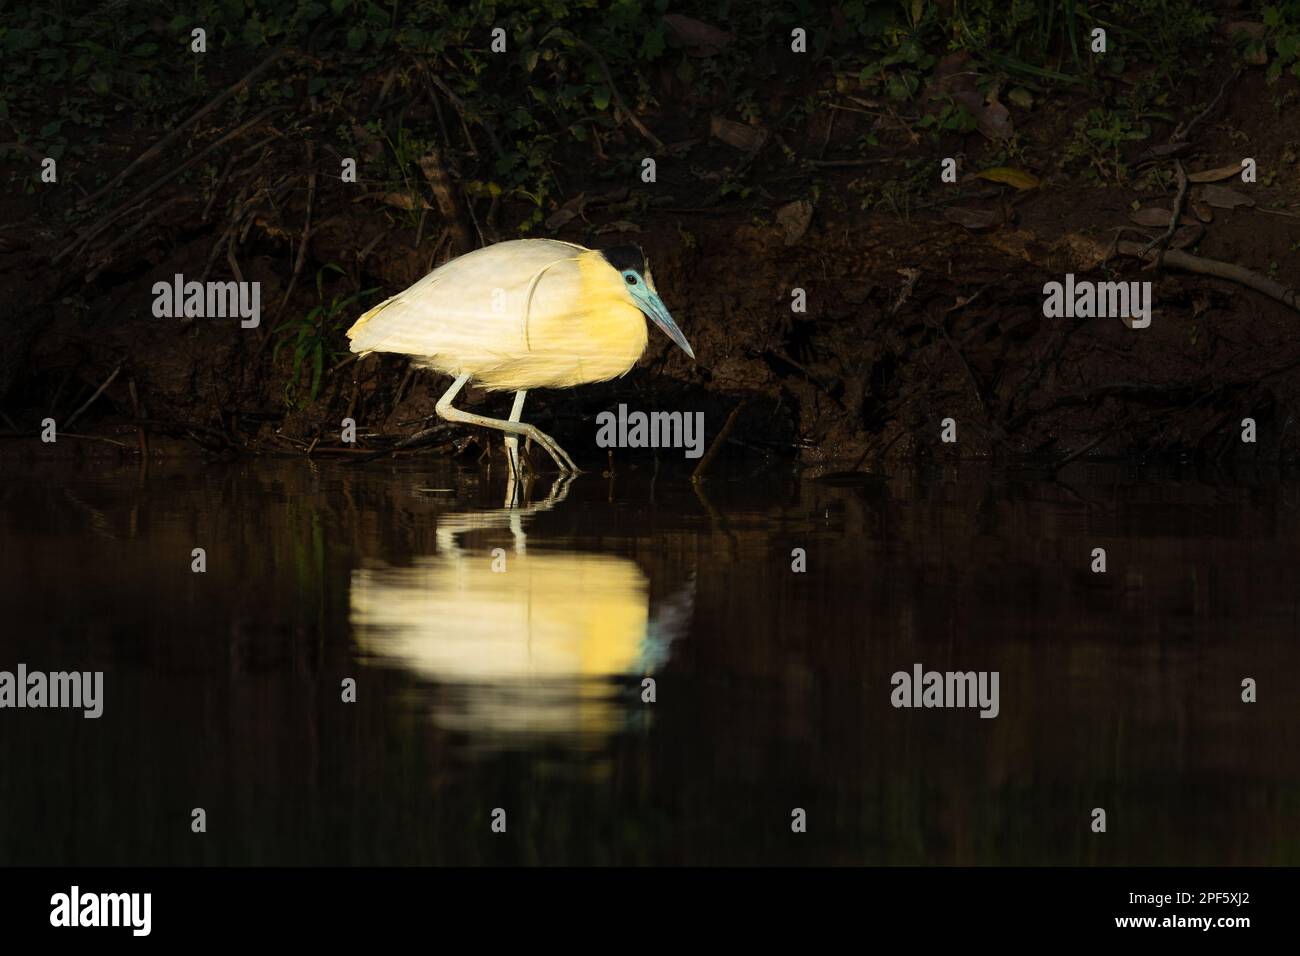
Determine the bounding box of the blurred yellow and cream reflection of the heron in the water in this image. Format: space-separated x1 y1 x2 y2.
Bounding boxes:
351 479 694 744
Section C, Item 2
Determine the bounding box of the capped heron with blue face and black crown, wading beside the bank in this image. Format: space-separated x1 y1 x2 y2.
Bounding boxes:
347 239 696 475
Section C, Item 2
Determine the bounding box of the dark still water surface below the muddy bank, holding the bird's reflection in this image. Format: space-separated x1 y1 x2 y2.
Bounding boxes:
0 460 1300 865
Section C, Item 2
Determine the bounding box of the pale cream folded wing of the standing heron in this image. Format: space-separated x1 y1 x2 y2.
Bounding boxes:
347 239 588 369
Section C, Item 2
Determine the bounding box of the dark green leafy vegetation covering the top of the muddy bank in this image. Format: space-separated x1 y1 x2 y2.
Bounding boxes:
0 0 1237 204
